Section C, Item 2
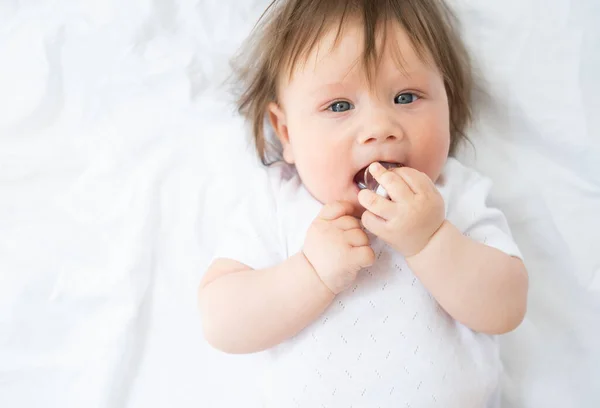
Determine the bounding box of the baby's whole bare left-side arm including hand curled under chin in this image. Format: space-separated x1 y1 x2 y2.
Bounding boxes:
199 203 375 353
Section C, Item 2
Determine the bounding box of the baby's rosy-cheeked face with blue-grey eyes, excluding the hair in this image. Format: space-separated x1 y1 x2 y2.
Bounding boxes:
270 19 450 216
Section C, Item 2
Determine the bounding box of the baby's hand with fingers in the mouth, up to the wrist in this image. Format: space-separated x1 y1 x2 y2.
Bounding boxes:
358 163 446 258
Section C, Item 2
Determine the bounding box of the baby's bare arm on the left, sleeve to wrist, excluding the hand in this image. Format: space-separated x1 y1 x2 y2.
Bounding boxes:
199 252 334 353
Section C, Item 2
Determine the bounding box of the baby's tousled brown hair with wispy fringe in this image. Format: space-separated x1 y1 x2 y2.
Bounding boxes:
236 0 473 164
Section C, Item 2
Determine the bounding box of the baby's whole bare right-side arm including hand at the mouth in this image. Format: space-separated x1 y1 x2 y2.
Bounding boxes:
359 165 528 334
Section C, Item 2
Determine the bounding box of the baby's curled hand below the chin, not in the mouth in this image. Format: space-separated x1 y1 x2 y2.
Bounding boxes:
302 202 375 295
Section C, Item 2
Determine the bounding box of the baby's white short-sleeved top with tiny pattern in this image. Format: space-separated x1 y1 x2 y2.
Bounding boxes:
216 158 520 408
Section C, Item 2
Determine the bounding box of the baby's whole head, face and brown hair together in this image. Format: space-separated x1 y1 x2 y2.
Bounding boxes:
239 0 472 215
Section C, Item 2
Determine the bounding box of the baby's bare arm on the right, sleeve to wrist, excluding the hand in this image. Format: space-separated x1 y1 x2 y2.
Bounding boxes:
406 221 528 334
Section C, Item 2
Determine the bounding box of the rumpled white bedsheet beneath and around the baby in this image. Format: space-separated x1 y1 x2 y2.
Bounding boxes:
0 0 600 408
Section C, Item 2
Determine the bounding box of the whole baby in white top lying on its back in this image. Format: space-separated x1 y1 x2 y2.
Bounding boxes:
199 0 528 408
